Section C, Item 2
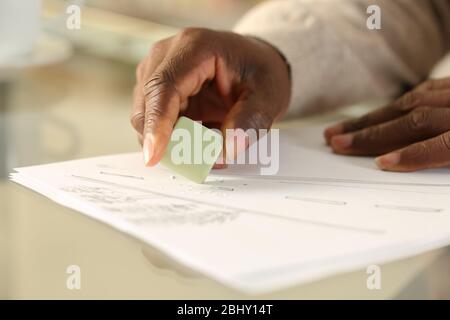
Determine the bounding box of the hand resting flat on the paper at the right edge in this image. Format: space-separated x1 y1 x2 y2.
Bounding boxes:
324 78 450 172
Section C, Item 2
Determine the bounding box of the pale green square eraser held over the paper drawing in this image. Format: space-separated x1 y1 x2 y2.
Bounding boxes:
161 117 223 183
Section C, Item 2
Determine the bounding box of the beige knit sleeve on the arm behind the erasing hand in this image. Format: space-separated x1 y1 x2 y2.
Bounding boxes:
235 0 450 116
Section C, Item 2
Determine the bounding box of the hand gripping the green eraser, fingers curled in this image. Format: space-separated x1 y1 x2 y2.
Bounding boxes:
131 28 291 166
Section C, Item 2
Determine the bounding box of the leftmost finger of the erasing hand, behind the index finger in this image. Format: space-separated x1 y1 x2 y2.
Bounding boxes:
130 38 171 135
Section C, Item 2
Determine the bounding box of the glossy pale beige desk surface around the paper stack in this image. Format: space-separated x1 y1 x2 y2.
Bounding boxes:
0 54 443 299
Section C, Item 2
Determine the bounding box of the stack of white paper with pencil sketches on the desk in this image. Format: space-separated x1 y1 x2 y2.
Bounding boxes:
12 127 450 294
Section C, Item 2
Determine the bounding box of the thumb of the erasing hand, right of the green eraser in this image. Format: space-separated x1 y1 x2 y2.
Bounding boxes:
221 95 277 160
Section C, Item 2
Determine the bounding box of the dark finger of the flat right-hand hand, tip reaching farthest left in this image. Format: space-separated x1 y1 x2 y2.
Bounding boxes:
324 105 405 144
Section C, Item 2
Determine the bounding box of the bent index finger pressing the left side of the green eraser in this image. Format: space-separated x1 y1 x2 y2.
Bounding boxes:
143 48 216 166
